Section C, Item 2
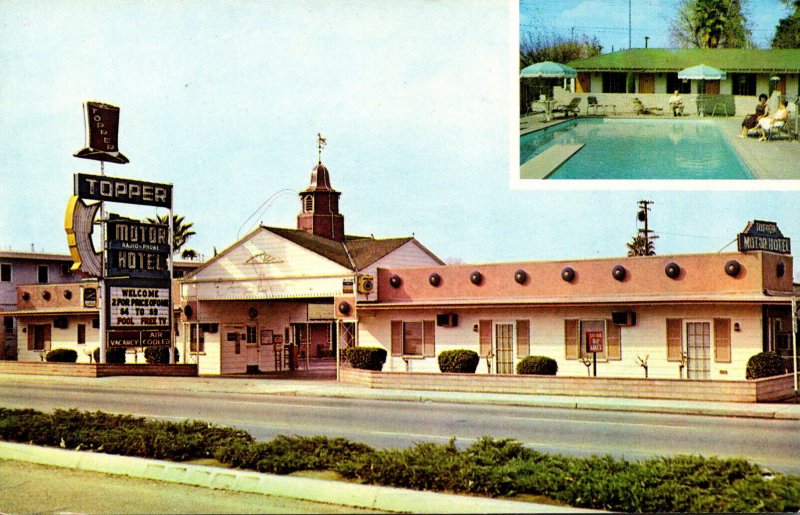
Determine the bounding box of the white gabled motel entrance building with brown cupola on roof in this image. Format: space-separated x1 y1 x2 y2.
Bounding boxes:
176 158 443 375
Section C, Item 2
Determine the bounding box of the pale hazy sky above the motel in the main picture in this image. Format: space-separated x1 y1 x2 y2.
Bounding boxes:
0 0 800 280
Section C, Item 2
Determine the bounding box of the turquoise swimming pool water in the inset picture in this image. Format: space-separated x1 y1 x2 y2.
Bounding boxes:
520 118 754 179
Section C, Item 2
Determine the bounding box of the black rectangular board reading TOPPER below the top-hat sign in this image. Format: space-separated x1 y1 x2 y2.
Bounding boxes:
74 173 172 209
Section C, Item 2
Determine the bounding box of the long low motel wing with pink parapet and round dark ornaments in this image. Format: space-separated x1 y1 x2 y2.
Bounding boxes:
358 222 793 380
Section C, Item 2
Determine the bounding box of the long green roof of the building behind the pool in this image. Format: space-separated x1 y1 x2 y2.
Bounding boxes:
567 48 800 73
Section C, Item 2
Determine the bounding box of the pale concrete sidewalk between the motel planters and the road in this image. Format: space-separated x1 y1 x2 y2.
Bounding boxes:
0 374 800 420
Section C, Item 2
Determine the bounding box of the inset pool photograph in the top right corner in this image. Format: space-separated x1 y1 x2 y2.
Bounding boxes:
512 0 800 182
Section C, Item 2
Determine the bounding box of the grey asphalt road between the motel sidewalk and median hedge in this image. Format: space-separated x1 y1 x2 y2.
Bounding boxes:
0 382 800 474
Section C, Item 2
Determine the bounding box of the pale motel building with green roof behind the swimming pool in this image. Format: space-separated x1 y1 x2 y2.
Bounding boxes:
522 48 800 117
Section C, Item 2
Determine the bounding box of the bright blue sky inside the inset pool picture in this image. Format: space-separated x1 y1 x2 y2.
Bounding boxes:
519 0 789 53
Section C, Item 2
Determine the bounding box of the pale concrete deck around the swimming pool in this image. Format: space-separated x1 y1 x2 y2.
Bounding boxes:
520 115 800 180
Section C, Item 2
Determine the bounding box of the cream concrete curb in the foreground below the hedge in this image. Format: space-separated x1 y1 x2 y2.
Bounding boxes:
0 442 598 513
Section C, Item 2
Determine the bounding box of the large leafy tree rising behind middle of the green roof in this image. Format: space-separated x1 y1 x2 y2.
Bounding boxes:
670 0 754 48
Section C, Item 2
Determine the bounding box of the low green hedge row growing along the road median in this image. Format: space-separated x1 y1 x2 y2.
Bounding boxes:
0 408 800 512
